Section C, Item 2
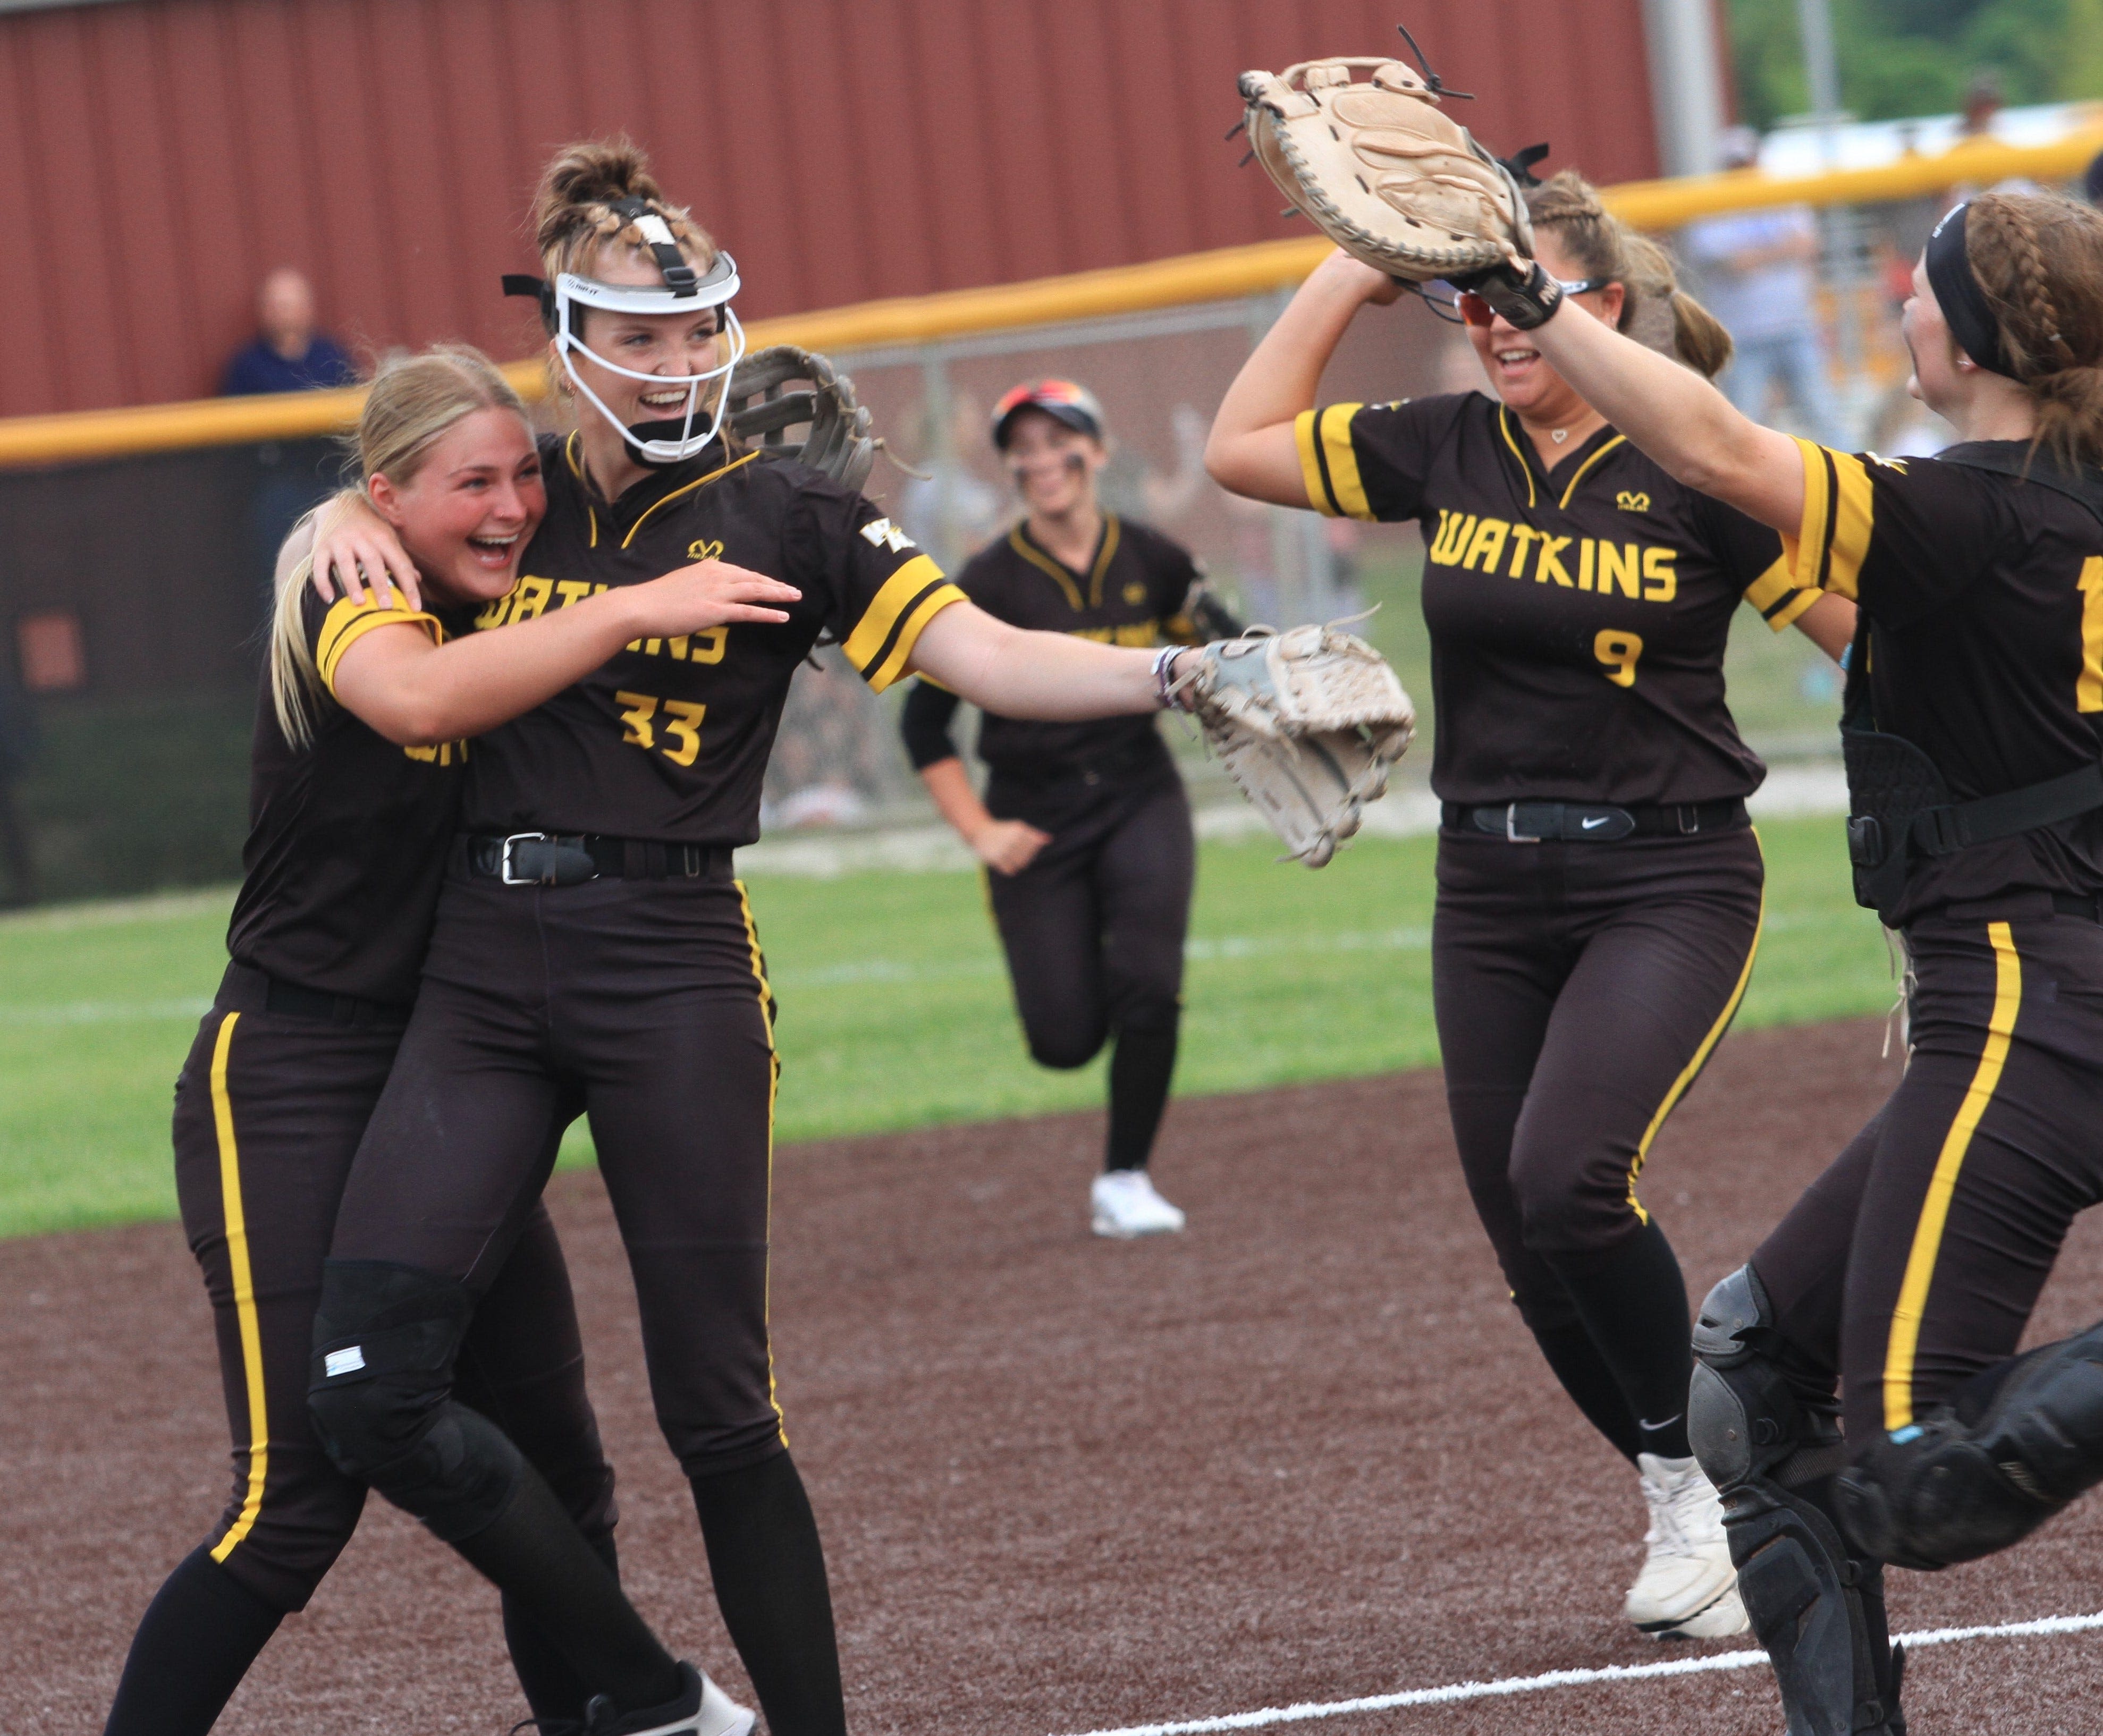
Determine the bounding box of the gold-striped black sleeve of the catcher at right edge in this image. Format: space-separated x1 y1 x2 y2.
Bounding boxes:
1784 439 2015 624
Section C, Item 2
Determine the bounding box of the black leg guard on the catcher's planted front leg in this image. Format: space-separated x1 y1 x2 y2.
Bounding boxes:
1687 1265 1905 1736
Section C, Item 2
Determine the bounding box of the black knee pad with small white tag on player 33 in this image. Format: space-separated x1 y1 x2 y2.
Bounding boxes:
307 1259 521 1540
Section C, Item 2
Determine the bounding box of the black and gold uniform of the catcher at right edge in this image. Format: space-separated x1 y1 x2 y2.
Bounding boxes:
1752 442 2103 1454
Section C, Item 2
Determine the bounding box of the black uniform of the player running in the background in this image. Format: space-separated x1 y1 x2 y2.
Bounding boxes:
902 515 1201 1076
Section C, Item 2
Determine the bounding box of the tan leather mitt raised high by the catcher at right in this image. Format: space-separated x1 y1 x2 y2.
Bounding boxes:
1241 57 1533 284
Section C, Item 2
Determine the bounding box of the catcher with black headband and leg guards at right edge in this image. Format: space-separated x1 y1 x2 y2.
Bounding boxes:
1483 193 2103 1732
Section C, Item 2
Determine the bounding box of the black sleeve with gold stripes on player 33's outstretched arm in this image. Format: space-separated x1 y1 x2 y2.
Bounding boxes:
795 490 965 693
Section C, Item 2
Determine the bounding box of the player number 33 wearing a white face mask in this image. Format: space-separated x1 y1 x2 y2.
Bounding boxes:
309 145 1220 1736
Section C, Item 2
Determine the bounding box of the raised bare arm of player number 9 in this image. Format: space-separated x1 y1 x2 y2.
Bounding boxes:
1205 250 1403 506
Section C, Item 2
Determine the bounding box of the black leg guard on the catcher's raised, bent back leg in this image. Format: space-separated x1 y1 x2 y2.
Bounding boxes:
1834 1324 2103 1572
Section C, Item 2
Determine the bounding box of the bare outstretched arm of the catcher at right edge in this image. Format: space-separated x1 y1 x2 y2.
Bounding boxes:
1514 292 1804 536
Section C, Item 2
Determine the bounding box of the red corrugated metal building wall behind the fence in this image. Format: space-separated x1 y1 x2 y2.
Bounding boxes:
0 0 1657 416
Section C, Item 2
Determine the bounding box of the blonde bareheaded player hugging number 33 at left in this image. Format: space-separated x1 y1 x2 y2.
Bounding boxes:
109 349 782 1736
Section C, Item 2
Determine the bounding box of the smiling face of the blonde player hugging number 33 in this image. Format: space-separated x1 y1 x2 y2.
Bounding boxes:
366 410 547 607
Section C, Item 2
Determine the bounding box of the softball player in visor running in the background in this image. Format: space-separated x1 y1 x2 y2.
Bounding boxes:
902 380 1241 1238
